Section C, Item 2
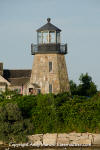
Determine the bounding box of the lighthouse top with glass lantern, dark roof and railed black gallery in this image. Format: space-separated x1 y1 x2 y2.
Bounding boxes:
31 18 67 55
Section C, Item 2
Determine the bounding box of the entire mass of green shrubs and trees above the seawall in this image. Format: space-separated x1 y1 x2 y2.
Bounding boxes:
0 74 100 142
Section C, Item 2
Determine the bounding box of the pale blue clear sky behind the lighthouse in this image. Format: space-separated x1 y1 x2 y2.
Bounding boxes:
0 0 100 89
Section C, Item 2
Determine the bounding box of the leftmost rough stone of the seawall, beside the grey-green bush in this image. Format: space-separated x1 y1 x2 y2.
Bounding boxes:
28 134 43 146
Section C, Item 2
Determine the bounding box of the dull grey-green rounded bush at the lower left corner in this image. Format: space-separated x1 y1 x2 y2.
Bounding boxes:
0 102 33 142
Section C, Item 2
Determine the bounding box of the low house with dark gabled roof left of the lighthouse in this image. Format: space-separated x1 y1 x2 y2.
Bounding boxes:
0 63 31 94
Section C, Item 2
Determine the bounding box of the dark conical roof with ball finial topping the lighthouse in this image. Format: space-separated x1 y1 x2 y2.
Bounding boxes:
37 18 61 32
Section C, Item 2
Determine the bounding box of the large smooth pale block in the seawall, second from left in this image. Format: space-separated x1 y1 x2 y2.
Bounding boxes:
43 133 57 146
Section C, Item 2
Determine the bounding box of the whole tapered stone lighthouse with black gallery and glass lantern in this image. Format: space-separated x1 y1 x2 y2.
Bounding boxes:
30 18 70 94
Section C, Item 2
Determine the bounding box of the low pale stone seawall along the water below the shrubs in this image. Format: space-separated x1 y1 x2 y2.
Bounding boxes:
28 133 100 146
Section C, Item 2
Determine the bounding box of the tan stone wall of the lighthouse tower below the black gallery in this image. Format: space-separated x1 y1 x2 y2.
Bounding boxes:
30 54 70 94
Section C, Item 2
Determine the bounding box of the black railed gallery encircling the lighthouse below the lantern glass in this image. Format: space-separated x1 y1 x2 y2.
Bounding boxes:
31 44 67 55
